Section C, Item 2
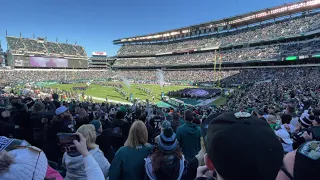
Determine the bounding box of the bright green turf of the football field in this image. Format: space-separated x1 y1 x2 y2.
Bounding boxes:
49 84 187 103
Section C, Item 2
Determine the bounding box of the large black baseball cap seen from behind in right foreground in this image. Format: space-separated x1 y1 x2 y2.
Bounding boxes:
206 112 284 180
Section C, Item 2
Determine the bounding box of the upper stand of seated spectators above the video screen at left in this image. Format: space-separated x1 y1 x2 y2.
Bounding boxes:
6 36 87 57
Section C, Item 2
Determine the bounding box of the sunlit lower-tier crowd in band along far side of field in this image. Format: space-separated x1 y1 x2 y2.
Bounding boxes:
0 69 239 85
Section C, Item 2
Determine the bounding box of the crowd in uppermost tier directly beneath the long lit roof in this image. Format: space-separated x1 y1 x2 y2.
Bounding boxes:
118 13 320 56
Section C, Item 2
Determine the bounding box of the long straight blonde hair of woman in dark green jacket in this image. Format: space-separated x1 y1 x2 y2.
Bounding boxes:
124 120 148 148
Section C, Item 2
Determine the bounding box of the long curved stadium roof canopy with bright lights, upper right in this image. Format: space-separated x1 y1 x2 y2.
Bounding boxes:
113 0 320 44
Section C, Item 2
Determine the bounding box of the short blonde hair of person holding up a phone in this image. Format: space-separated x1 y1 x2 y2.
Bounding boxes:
77 124 97 148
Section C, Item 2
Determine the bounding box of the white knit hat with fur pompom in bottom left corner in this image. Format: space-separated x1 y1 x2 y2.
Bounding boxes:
0 137 48 180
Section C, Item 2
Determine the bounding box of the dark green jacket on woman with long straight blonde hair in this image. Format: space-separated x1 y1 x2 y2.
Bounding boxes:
109 145 153 180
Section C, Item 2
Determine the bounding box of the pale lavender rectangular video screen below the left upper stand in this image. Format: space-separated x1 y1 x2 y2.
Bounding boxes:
30 57 68 67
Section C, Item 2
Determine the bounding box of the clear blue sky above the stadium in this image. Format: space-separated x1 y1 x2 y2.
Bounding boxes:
0 0 292 55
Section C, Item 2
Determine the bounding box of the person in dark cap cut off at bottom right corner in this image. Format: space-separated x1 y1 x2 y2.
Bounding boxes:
276 141 320 180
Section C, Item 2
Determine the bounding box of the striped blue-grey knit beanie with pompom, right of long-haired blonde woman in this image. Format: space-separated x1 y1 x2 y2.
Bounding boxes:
158 128 178 154
